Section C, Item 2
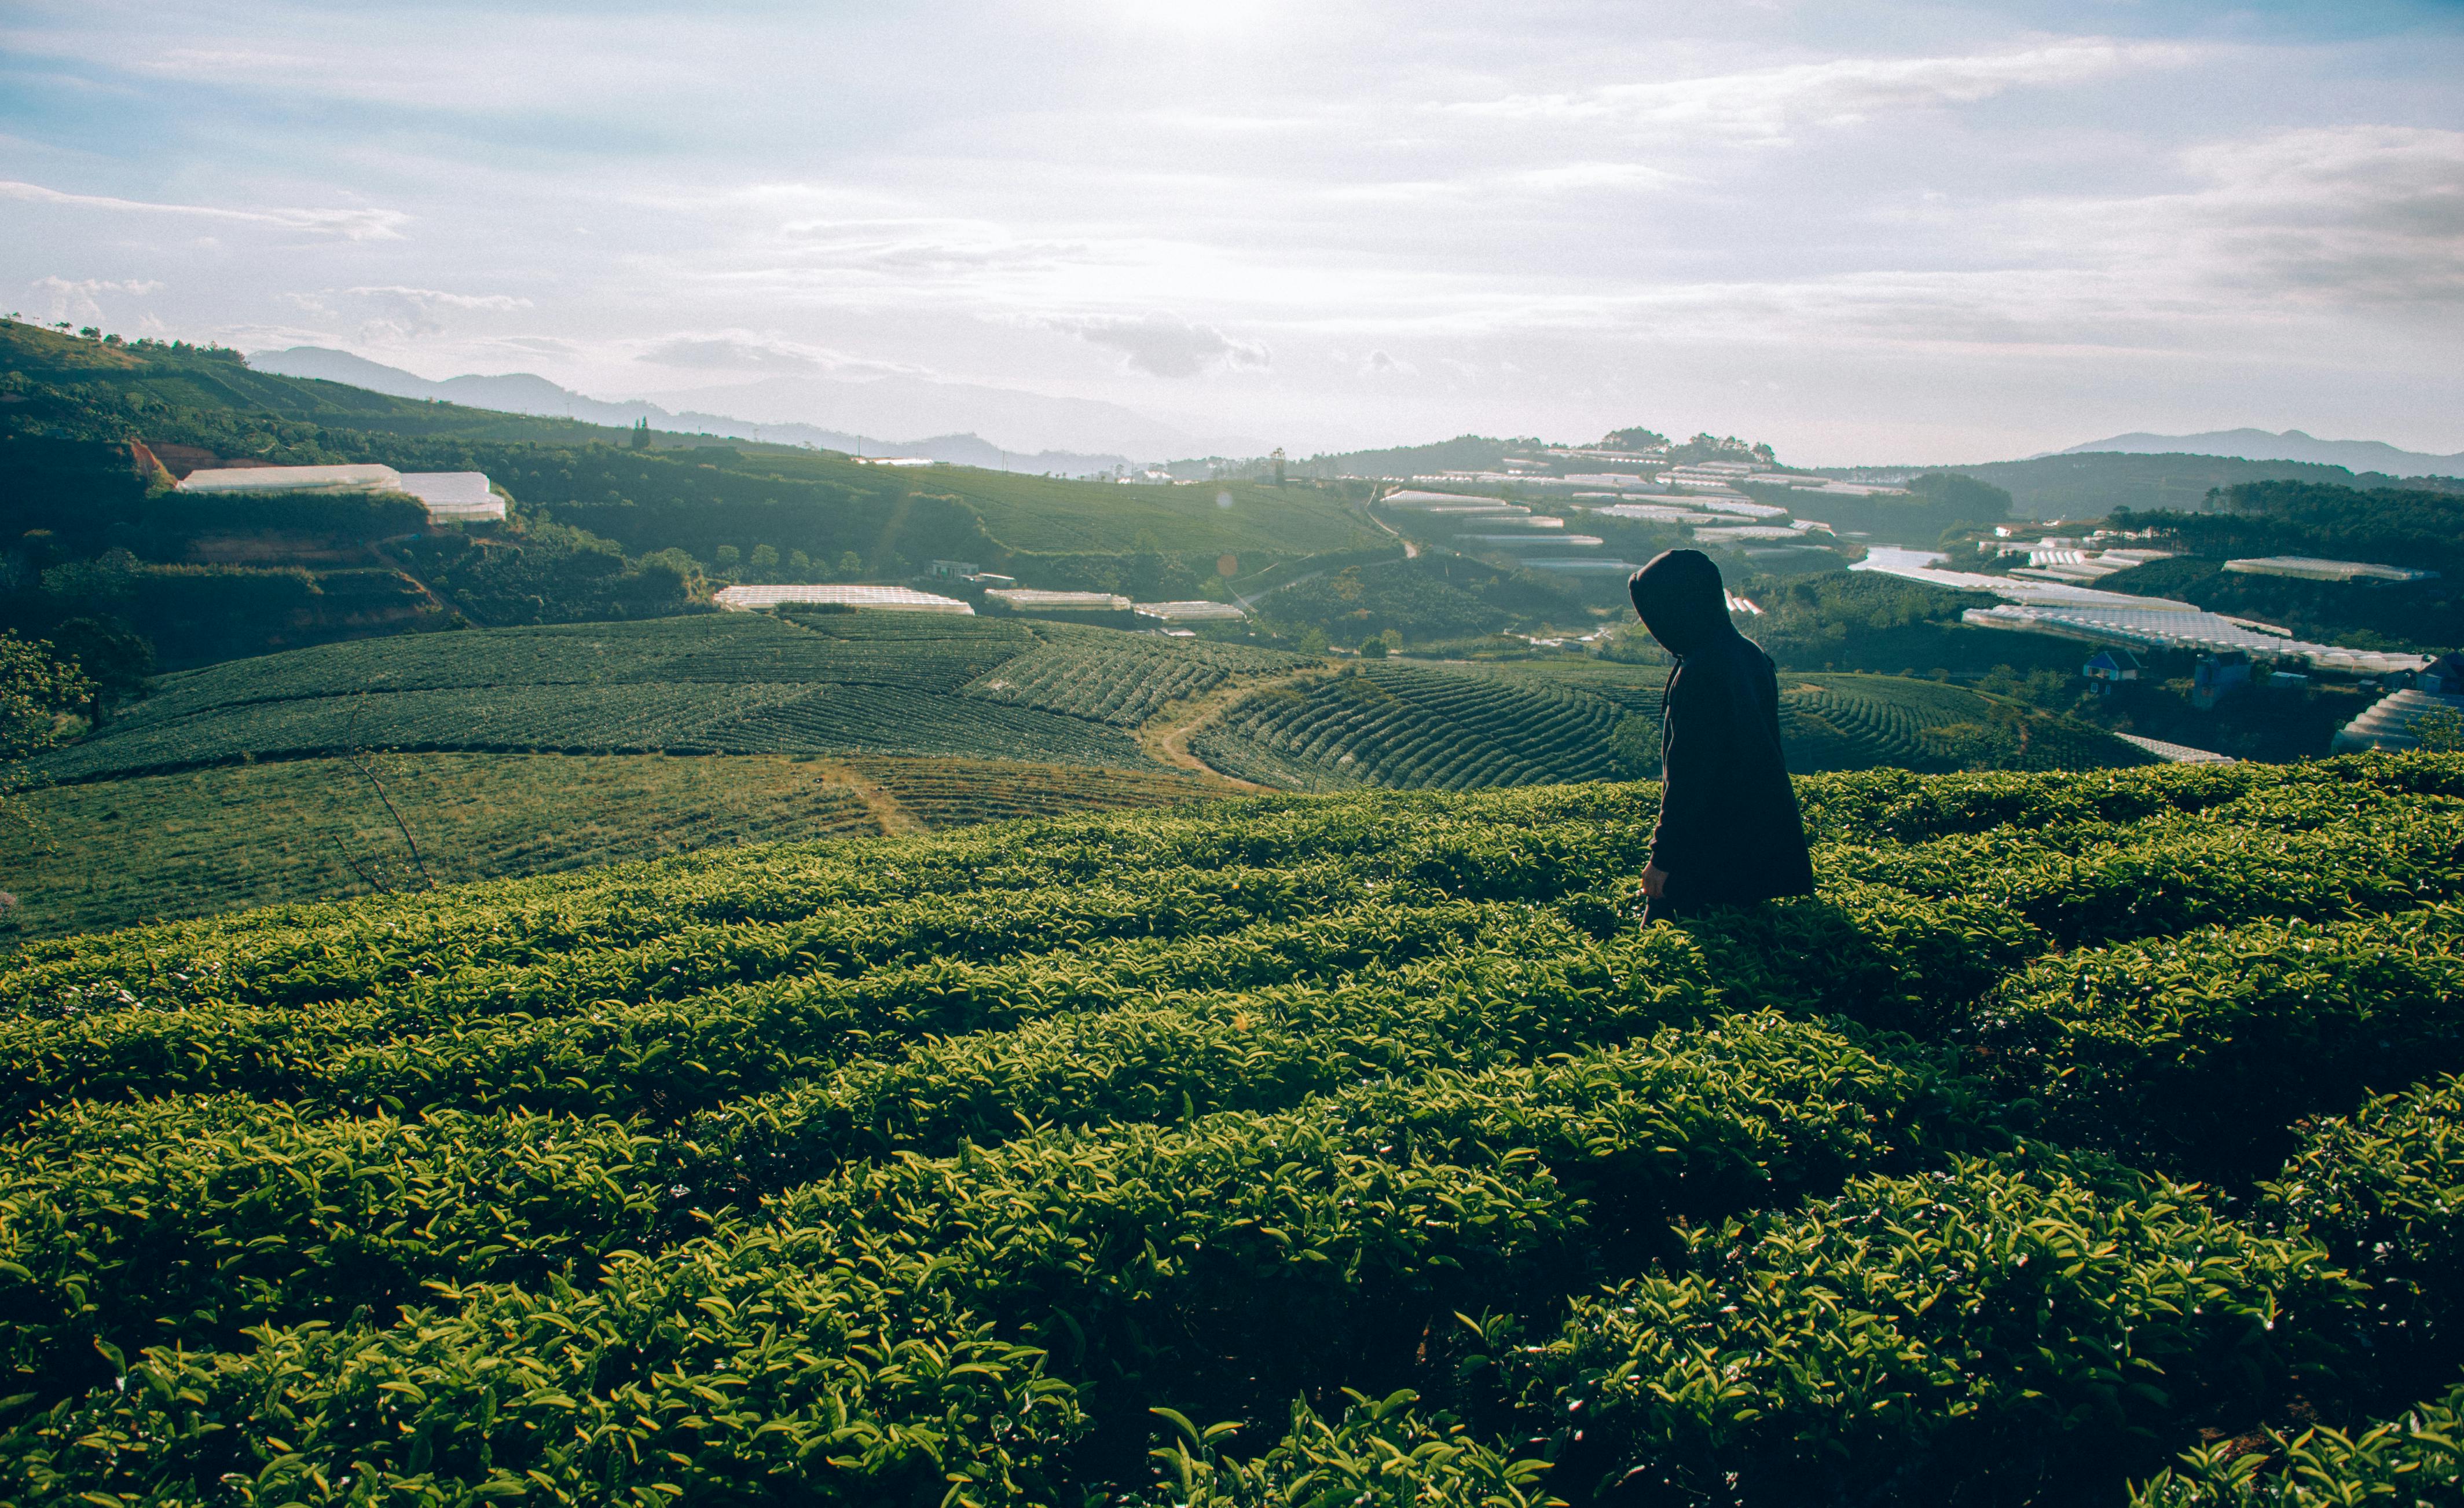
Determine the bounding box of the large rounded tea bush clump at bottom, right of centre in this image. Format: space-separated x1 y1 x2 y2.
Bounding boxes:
1508 1153 2360 1503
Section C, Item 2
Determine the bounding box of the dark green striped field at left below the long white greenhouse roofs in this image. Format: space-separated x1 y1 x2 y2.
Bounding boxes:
39 613 1247 781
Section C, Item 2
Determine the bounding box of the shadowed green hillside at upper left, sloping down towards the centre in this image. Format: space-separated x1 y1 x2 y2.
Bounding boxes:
0 320 1373 665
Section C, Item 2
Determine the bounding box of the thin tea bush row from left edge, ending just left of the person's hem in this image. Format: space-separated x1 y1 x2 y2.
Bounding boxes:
0 902 1562 1114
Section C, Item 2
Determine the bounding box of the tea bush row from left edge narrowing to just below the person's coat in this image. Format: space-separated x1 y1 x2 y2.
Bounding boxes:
0 931 1707 1377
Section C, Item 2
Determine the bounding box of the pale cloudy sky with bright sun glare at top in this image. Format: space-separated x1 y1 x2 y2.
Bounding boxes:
0 0 2464 466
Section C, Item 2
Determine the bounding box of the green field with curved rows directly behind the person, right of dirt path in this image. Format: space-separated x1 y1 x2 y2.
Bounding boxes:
1190 660 2151 791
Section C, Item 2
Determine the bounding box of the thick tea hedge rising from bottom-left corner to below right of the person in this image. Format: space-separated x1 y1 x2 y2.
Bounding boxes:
0 1017 1981 1500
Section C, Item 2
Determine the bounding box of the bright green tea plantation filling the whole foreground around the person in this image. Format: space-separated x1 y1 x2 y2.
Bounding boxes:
0 756 2464 1508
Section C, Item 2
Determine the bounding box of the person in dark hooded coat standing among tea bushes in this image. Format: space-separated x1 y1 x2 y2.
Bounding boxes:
1626 550 1813 919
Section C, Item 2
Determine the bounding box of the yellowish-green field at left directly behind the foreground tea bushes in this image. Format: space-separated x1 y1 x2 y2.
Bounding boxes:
0 754 1220 936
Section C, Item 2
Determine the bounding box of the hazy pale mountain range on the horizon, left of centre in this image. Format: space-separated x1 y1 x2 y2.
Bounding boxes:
249 345 1264 475
